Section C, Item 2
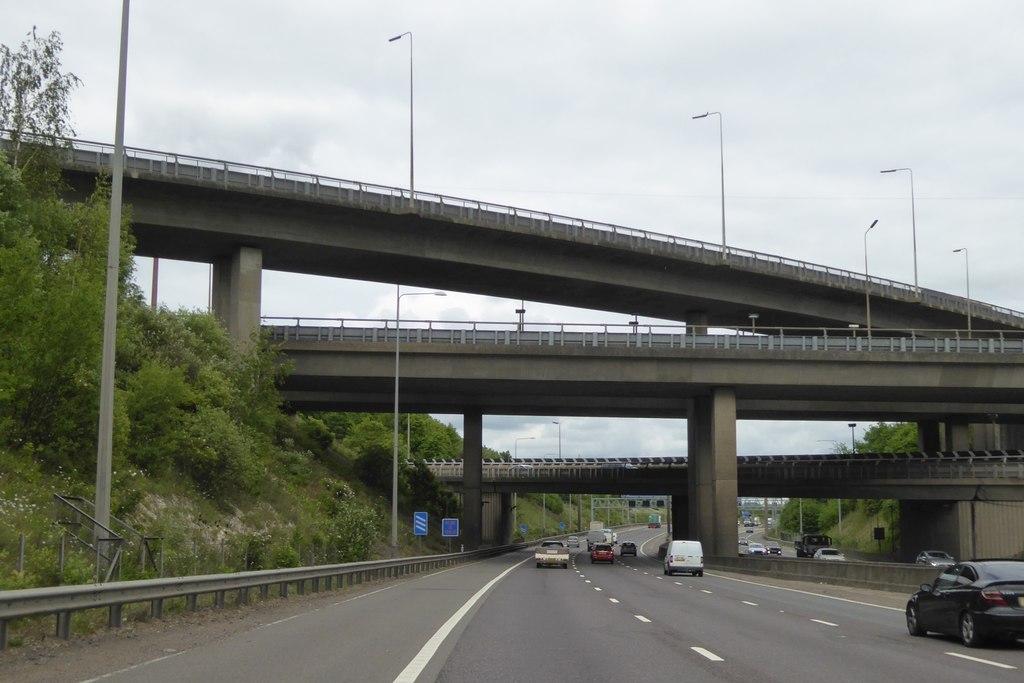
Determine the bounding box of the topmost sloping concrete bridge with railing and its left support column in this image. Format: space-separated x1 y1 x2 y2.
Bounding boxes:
44 141 1024 337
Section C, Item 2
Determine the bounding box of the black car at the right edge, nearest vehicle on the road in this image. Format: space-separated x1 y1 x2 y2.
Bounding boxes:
906 560 1024 647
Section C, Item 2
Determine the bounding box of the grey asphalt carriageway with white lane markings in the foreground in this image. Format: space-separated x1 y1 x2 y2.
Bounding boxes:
0 527 1024 683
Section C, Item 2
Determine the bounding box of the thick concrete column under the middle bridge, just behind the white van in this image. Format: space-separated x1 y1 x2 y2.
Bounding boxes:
687 387 738 556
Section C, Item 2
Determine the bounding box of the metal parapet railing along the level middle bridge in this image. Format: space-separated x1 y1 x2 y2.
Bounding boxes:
263 316 1024 353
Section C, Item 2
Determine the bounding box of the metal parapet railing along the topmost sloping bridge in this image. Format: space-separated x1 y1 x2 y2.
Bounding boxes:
12 131 1024 328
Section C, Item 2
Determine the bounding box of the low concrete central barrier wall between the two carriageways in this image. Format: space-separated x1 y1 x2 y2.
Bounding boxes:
705 557 939 595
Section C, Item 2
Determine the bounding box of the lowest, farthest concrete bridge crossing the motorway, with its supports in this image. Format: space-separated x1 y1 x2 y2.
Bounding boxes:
427 450 1024 561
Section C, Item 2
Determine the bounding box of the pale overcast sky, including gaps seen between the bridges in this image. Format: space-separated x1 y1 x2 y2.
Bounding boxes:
8 0 1024 457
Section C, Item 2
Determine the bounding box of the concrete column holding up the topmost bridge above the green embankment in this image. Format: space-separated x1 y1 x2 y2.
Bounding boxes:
213 247 263 342
